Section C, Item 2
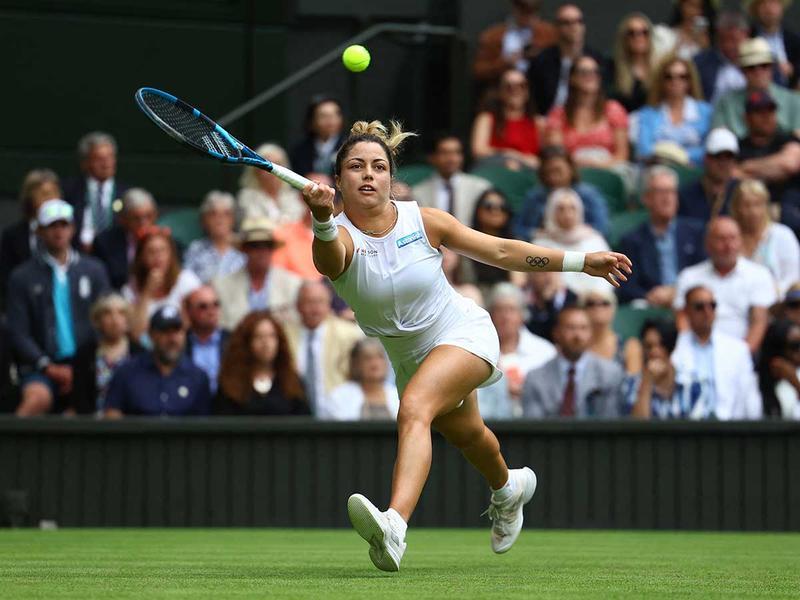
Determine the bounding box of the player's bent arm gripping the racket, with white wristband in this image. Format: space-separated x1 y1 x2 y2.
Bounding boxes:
303 182 353 279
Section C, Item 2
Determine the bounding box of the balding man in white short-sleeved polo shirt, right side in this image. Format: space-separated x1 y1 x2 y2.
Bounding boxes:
673 217 777 354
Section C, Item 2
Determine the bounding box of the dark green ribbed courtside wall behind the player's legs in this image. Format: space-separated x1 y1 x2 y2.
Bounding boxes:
0 418 800 531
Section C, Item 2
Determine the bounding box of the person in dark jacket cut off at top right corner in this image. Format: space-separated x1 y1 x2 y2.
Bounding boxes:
743 0 800 88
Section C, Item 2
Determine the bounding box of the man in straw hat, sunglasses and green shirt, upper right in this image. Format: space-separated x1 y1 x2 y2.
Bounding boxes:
711 38 800 138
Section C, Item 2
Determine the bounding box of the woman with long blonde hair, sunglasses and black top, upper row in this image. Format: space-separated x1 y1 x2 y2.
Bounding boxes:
611 12 656 113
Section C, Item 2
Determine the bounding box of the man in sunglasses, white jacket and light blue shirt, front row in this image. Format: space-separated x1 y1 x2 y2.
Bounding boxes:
672 285 762 421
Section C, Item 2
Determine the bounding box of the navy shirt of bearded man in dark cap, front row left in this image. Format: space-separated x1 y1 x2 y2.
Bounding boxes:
106 352 211 416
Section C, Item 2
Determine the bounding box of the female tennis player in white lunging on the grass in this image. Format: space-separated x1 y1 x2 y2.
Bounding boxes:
303 121 631 571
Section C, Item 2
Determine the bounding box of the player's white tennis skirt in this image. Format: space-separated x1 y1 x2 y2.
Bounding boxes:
379 294 503 397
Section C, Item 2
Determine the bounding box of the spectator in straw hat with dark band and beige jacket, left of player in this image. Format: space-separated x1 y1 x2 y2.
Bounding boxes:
211 217 303 330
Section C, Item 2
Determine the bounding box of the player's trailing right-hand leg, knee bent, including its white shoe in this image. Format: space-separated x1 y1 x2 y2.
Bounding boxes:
433 392 536 553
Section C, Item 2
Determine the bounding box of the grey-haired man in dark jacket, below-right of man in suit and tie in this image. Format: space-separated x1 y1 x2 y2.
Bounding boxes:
92 188 158 290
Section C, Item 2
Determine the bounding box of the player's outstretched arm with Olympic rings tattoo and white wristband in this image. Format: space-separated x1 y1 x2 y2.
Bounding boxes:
421 208 632 287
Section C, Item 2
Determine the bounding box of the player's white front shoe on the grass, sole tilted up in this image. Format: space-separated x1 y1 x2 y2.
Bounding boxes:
347 494 406 571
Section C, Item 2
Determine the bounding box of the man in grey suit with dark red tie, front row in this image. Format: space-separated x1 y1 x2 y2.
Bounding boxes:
522 306 625 419
